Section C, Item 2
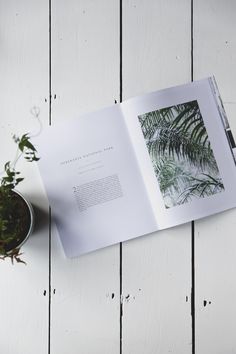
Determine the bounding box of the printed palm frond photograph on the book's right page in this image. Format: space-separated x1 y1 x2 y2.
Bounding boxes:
138 100 224 208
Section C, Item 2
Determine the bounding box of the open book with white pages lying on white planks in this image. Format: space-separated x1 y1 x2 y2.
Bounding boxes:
34 78 236 257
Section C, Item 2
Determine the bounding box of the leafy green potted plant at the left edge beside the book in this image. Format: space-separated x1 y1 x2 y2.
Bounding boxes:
0 134 39 263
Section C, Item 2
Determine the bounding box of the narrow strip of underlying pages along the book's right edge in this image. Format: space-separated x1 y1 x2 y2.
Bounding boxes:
209 76 236 165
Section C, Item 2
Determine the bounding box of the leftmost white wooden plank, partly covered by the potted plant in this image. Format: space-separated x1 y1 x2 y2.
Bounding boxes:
0 0 48 354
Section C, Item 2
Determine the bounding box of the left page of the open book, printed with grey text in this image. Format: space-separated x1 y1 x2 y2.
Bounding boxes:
34 105 157 257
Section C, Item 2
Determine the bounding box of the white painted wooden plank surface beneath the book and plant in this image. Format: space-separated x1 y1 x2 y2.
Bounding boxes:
0 0 236 354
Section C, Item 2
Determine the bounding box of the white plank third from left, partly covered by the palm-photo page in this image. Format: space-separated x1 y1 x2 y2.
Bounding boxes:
122 0 191 354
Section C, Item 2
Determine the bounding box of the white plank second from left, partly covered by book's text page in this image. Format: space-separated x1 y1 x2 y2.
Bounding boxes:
51 0 119 354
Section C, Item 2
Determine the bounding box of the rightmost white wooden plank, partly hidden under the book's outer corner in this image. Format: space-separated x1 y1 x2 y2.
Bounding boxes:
193 0 236 354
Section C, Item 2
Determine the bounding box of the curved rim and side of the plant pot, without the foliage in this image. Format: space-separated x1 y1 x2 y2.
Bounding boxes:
3 190 34 253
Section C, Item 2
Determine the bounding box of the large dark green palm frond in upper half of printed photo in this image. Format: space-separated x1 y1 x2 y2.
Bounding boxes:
139 101 217 170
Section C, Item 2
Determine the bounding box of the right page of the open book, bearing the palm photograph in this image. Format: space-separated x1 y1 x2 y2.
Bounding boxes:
121 78 236 229
